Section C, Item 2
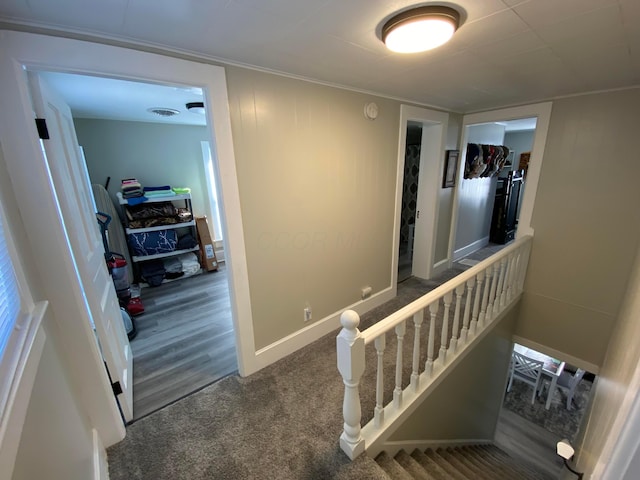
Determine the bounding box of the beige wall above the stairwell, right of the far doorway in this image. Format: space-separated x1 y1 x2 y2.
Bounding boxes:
517 89 640 365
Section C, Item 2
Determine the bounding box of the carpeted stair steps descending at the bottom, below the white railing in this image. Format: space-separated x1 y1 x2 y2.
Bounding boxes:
376 445 548 480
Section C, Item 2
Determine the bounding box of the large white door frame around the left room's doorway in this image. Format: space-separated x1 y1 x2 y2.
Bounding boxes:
0 31 257 446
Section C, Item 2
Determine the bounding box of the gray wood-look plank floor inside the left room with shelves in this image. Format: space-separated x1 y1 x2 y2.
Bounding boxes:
131 266 237 420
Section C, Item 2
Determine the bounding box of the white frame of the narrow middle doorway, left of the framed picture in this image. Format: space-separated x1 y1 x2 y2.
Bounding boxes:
391 105 449 284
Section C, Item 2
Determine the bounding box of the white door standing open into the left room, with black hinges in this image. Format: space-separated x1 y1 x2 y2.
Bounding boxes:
29 72 133 421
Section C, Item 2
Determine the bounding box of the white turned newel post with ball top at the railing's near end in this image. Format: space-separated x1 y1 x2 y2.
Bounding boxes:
336 310 364 460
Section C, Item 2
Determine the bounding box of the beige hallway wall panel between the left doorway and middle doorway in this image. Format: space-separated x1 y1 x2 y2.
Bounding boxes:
226 67 400 348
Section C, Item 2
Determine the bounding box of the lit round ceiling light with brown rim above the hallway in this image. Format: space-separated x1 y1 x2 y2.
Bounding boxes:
382 5 460 53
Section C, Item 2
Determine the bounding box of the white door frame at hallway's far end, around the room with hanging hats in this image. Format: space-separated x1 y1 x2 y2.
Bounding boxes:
449 102 553 268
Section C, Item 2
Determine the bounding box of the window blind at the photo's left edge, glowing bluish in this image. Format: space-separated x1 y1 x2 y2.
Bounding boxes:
0 214 20 358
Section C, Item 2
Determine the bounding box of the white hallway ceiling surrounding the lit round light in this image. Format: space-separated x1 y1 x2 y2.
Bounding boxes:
0 0 640 113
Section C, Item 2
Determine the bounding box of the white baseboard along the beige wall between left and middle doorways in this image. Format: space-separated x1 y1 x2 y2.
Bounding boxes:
255 287 395 371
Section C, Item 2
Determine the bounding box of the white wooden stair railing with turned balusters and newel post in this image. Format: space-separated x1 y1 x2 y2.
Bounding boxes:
336 236 532 460
